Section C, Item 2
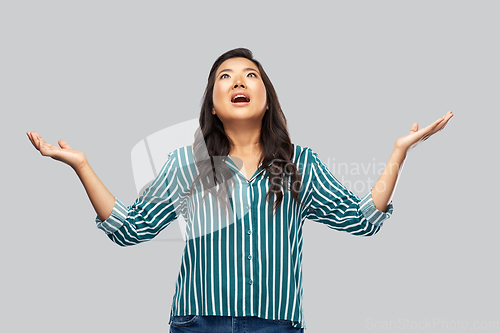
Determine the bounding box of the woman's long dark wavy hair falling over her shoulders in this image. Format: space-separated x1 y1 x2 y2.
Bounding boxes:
191 48 302 218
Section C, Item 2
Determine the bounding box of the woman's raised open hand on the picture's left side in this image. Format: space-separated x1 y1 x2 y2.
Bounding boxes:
26 132 87 170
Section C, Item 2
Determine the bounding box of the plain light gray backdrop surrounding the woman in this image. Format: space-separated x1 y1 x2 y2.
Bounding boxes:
0 0 500 333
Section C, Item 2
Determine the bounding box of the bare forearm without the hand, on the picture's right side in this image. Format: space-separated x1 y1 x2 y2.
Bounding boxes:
371 148 406 212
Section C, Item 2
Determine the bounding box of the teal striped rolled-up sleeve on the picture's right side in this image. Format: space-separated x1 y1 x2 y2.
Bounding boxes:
305 148 393 236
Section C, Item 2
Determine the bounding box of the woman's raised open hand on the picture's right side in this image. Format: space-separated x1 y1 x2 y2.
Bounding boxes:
394 111 453 155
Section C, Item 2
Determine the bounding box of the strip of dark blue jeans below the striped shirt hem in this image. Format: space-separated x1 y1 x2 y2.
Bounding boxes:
170 315 304 333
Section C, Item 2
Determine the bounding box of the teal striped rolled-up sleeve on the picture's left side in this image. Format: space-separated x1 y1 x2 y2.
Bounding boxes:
95 151 180 246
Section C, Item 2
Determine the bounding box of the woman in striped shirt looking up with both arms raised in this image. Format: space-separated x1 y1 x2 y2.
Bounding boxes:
27 48 453 332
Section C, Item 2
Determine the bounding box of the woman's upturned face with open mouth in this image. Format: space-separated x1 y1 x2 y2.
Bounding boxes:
212 58 267 125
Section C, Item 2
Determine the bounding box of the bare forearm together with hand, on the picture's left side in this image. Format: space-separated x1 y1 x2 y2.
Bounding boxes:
26 132 115 221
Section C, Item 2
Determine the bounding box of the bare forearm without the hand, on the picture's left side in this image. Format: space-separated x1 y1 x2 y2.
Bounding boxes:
74 161 115 221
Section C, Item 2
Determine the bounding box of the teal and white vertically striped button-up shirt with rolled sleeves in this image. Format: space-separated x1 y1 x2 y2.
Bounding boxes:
96 145 393 329
